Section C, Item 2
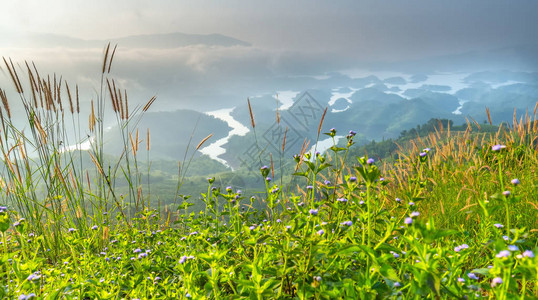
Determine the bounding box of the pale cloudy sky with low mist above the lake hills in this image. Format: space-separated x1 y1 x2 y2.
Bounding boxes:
0 0 538 108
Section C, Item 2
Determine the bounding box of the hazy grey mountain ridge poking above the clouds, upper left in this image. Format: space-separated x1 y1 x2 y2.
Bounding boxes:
0 32 251 49
